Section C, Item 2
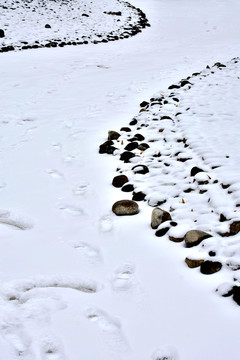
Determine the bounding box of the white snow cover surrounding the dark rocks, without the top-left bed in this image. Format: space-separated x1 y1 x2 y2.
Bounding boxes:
0 0 240 360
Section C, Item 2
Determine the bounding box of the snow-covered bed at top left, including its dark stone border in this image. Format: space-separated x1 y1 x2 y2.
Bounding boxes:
0 0 150 53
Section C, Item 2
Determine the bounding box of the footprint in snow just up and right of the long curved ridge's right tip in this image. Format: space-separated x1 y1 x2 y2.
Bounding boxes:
111 264 135 291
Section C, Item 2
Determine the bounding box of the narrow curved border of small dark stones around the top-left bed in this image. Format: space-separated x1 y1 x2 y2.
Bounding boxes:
0 0 151 53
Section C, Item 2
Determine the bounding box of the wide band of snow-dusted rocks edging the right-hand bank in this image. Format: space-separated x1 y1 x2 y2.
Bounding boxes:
99 58 240 305
